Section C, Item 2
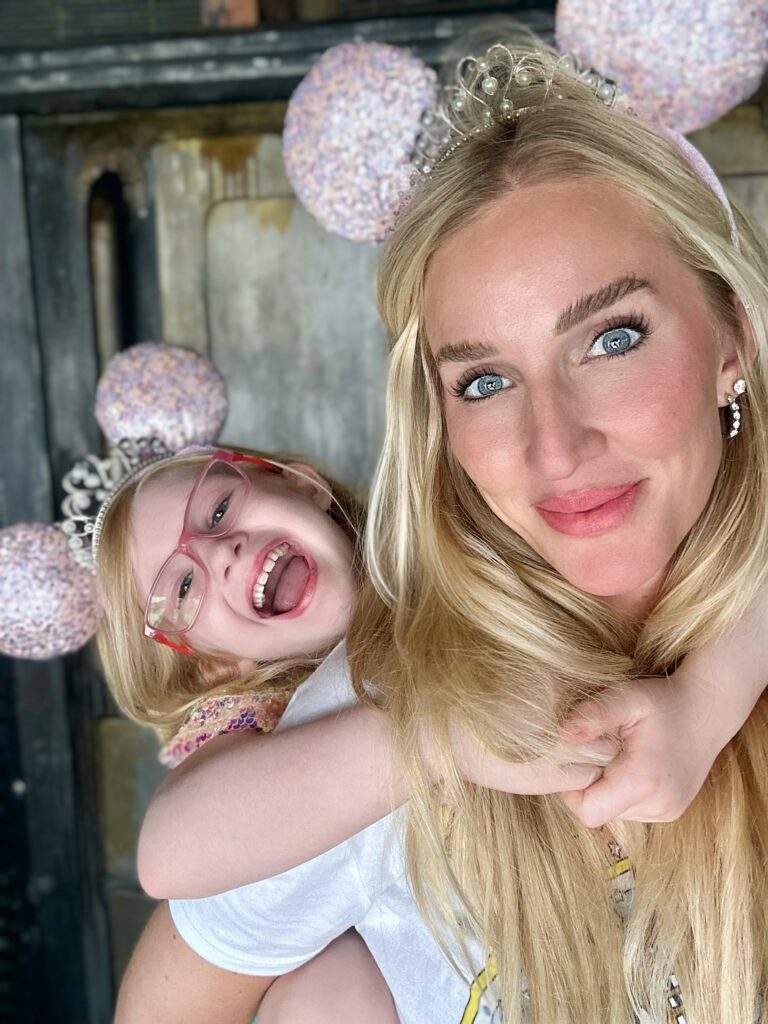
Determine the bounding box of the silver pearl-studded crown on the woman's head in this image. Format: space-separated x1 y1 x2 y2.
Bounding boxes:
411 43 617 175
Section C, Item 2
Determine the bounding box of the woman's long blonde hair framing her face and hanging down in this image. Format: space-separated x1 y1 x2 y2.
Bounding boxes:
348 29 768 1024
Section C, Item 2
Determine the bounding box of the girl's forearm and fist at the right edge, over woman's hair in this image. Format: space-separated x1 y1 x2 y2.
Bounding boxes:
563 595 768 827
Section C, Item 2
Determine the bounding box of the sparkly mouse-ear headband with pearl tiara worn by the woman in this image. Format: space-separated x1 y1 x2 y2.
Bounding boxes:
283 0 768 244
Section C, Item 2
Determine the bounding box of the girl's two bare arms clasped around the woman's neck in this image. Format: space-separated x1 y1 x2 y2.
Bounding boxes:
138 599 768 898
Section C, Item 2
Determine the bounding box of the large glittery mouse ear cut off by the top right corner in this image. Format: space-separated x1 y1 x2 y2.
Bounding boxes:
555 0 768 134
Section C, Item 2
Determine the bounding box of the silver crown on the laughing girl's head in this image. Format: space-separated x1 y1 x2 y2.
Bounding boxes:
58 437 173 571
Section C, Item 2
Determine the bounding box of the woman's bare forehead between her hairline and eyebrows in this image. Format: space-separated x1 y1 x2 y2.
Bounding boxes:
425 180 685 347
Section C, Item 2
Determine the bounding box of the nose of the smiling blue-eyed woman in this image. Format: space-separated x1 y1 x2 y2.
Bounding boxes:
525 388 605 480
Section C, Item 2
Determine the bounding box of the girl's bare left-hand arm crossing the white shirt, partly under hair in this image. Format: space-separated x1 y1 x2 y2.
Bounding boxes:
137 706 615 899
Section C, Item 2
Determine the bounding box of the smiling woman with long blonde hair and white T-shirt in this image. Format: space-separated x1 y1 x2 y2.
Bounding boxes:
118 34 768 1024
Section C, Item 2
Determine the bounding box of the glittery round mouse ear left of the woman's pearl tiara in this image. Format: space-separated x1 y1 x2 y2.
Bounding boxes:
283 43 437 242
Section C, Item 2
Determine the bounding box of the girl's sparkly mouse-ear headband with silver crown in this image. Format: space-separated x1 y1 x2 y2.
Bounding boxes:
0 342 227 658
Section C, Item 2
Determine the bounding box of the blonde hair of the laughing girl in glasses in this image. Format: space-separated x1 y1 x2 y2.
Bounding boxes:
97 449 364 741
